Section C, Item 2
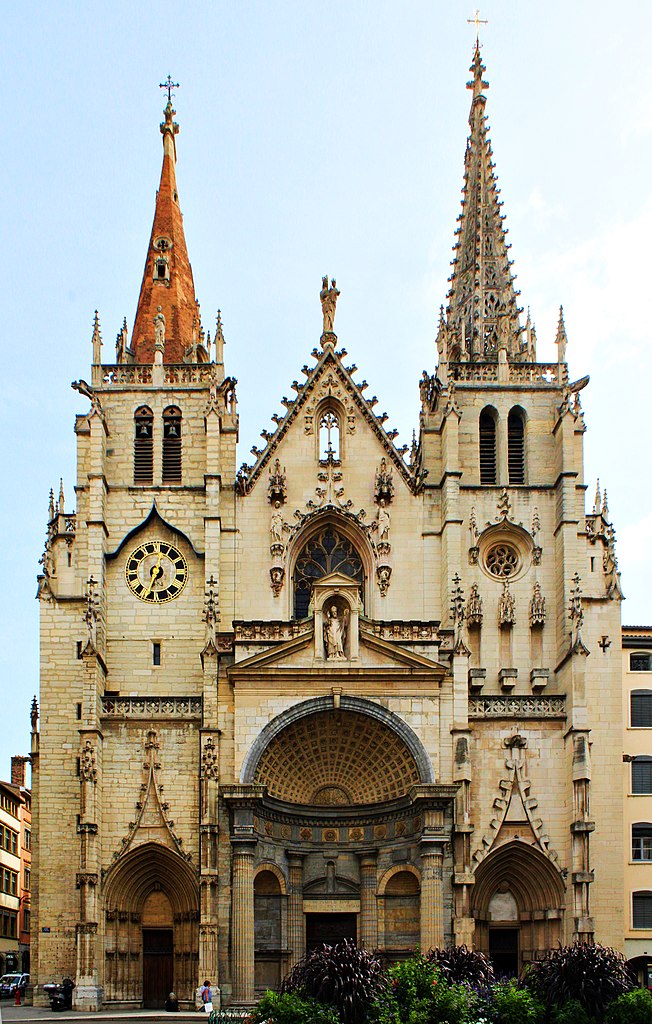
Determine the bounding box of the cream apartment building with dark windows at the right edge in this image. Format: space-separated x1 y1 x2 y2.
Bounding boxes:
622 626 652 985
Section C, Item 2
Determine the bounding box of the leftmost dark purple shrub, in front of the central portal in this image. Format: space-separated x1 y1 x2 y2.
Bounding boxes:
282 939 386 1024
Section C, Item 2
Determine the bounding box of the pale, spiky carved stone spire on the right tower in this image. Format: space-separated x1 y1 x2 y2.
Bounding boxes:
446 42 522 361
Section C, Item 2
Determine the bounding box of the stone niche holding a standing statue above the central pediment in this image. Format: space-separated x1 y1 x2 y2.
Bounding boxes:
309 572 362 668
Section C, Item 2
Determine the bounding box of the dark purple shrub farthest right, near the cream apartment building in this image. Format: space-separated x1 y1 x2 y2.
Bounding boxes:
524 943 635 1021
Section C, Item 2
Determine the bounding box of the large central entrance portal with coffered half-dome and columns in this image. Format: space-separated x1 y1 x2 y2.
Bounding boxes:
229 695 457 1001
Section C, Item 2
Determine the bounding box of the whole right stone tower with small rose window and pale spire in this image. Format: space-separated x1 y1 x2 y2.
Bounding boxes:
417 45 622 949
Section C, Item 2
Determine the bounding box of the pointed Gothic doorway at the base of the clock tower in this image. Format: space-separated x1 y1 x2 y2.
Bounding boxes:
103 843 199 1009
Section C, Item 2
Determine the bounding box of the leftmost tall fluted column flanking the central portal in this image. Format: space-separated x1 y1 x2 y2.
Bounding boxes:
231 843 255 1004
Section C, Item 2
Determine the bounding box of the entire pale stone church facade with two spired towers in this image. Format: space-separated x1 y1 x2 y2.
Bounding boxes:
32 47 623 1009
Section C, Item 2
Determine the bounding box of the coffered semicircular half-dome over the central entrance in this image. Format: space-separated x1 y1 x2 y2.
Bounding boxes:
242 697 434 806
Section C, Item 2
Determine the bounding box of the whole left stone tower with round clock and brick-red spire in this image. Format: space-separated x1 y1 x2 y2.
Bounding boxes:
34 94 237 1010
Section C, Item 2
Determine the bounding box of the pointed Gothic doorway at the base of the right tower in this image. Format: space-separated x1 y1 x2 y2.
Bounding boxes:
473 840 565 975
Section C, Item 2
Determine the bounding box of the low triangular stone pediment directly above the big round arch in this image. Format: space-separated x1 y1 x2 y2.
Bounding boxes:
228 618 448 683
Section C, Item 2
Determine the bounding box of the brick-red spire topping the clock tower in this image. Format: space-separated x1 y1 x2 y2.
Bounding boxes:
131 99 200 362
